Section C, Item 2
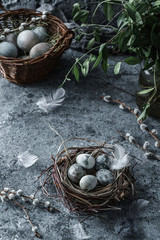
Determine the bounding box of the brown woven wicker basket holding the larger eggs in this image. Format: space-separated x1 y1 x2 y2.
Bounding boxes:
0 2 73 84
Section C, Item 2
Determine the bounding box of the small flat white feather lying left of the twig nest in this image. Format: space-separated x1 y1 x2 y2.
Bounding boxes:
17 151 38 168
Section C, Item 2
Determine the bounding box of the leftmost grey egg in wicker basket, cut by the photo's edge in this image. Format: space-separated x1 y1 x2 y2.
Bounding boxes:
0 42 18 58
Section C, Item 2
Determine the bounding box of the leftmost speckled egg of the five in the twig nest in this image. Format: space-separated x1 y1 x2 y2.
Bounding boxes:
68 163 84 183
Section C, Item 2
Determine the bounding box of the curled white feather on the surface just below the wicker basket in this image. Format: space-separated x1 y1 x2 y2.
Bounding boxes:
36 88 66 113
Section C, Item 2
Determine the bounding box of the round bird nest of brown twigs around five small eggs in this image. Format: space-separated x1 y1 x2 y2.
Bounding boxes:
42 138 135 213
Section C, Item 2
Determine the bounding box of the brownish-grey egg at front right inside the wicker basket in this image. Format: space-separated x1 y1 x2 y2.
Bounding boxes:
29 43 50 58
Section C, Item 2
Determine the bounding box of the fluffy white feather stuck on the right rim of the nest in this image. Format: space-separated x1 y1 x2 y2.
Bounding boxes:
110 144 129 170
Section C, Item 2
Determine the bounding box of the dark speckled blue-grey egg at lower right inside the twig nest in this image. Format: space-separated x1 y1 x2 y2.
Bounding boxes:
96 169 114 186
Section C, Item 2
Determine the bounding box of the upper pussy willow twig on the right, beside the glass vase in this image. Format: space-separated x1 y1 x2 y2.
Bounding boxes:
100 96 160 146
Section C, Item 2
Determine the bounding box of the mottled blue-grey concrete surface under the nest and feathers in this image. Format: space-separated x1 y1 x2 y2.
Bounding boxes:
0 50 160 240
